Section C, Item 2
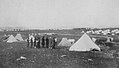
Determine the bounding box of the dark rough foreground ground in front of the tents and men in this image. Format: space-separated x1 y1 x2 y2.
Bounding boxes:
0 42 119 68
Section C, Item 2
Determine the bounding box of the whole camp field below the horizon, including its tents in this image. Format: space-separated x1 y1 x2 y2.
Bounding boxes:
0 30 119 68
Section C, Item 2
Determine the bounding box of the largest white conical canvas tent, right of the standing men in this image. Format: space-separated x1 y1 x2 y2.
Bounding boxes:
69 33 100 51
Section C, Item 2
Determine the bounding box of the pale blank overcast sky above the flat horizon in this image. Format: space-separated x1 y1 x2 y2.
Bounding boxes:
0 0 119 28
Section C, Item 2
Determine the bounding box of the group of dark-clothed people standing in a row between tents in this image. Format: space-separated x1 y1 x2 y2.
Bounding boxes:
27 36 57 49
